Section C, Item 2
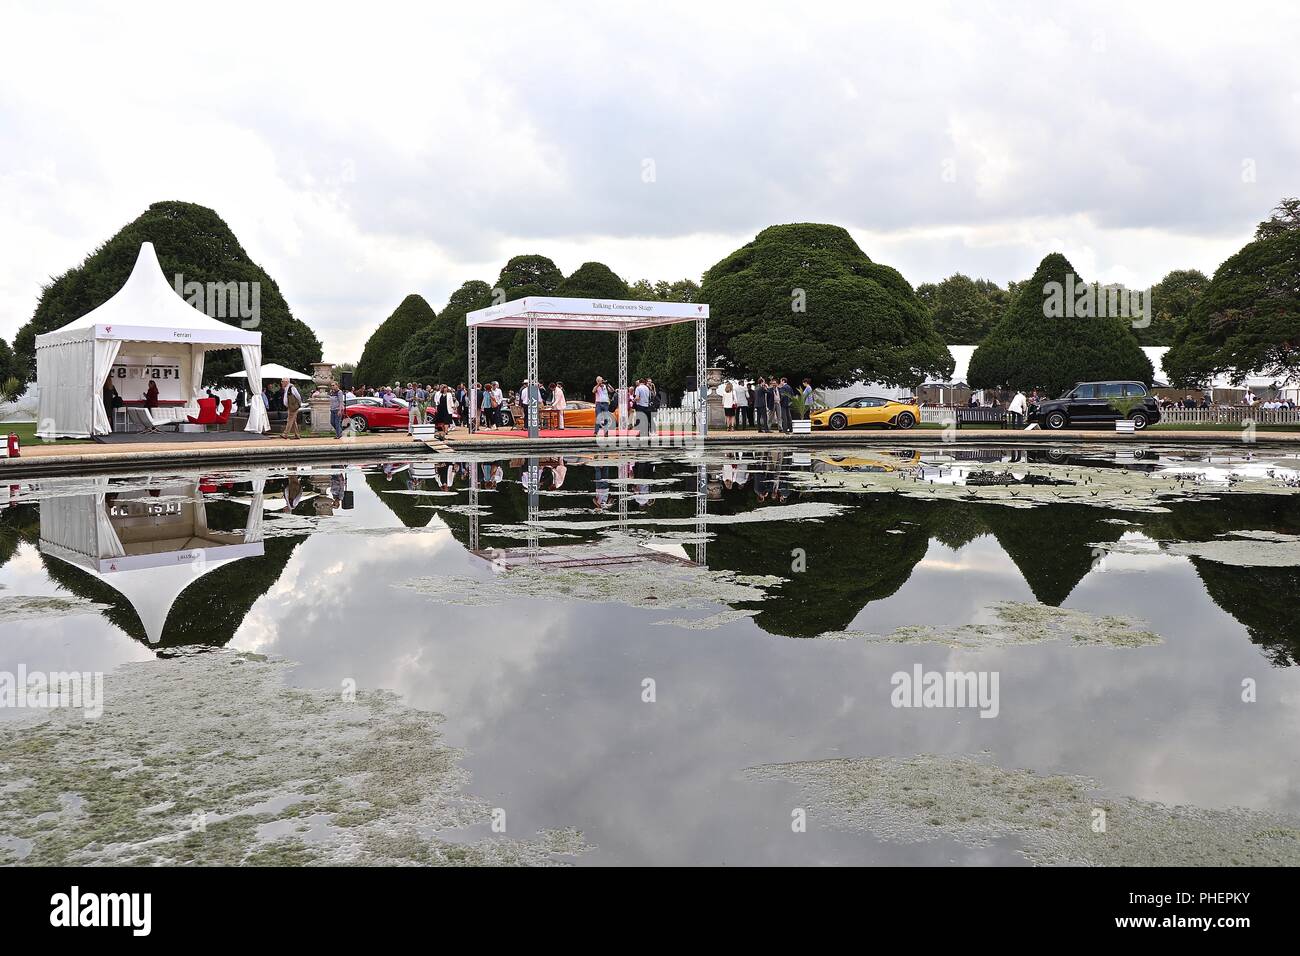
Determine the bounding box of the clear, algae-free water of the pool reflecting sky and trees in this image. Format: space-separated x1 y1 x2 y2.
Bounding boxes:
0 449 1300 864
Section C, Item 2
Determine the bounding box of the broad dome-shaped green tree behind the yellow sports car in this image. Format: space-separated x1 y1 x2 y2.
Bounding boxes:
699 222 953 386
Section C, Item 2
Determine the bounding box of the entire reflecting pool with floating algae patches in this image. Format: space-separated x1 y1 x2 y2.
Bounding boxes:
0 445 1300 865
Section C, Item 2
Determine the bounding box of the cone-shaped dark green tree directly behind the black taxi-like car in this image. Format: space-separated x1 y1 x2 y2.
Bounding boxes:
967 252 1153 395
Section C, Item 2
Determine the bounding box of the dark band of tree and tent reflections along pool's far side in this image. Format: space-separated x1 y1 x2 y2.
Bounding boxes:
0 449 1300 665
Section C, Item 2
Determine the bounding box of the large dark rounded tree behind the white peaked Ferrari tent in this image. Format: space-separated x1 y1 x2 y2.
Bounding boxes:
14 202 321 381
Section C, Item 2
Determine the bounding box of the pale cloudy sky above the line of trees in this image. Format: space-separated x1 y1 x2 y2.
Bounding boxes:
0 0 1300 362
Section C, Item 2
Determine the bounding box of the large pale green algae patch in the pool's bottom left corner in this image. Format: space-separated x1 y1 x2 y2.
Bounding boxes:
0 652 585 866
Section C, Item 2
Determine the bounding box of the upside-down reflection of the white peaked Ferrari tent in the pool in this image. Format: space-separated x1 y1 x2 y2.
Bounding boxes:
40 479 265 645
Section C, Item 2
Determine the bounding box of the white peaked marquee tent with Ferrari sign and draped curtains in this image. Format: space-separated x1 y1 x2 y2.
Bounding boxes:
36 242 270 438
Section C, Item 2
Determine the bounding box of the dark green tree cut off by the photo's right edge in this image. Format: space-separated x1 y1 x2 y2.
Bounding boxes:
1164 199 1300 388
